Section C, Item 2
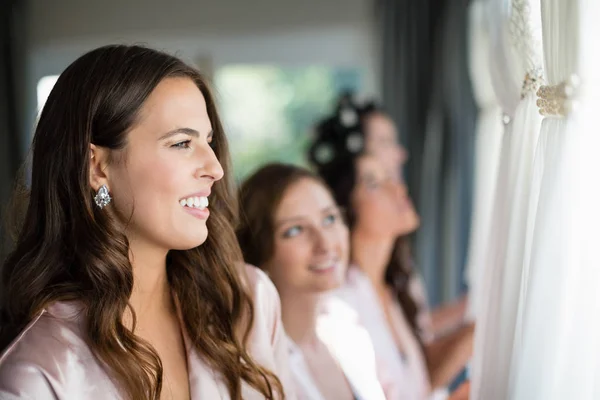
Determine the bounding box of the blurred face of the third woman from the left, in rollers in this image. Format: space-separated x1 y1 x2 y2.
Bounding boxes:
352 155 419 237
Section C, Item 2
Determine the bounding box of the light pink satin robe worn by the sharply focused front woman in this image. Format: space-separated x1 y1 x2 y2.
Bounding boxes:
0 266 295 400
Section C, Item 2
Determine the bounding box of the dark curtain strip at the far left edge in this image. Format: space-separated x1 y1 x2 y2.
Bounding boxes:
0 0 25 263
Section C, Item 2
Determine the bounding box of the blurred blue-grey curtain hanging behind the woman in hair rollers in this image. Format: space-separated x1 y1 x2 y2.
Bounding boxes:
379 0 476 305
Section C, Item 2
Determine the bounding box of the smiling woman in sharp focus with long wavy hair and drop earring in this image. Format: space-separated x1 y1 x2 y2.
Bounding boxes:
0 45 289 400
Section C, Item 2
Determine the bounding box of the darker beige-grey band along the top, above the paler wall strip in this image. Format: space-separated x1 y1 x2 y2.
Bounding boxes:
29 0 373 44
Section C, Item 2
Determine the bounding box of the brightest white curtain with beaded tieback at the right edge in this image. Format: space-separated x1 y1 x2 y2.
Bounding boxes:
511 0 600 400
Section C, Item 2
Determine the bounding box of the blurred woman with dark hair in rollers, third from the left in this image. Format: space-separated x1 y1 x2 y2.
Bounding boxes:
309 98 472 400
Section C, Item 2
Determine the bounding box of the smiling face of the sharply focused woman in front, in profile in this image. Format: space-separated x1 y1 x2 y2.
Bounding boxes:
92 78 223 250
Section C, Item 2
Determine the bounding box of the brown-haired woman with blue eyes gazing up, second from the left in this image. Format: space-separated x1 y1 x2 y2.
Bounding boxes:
237 164 397 400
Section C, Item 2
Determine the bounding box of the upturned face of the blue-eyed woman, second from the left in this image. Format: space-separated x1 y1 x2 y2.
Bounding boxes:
263 178 349 295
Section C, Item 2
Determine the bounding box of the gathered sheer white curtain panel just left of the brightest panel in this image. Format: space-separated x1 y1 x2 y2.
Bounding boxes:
473 0 544 399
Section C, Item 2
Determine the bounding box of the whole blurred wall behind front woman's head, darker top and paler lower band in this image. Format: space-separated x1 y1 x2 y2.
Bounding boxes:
27 0 380 143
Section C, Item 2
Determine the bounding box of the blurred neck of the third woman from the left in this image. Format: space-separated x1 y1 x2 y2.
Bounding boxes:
350 231 396 290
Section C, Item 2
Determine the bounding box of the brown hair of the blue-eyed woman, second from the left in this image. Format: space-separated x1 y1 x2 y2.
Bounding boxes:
236 163 327 266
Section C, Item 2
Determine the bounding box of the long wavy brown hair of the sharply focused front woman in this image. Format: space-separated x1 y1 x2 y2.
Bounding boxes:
1 45 284 400
